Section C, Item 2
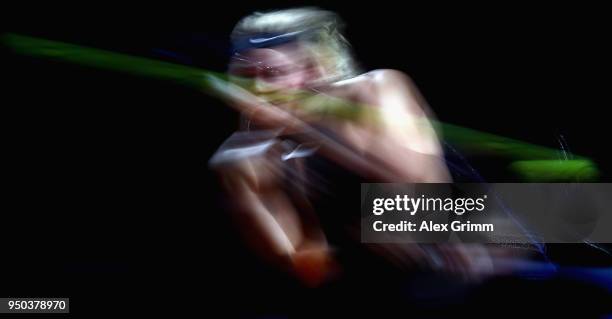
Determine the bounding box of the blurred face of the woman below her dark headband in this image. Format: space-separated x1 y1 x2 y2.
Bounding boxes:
230 45 320 97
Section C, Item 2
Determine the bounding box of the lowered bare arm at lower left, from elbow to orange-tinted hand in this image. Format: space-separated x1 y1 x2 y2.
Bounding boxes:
220 154 334 286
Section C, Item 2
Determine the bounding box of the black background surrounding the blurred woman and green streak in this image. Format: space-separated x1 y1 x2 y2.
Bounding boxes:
0 2 610 313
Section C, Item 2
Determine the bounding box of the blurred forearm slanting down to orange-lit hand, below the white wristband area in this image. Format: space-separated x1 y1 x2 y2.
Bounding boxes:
220 169 335 286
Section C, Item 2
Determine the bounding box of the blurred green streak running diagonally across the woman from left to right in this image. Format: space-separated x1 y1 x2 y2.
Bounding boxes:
1 34 599 181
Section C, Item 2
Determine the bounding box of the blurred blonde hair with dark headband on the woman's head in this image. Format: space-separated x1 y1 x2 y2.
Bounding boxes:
231 7 358 82
